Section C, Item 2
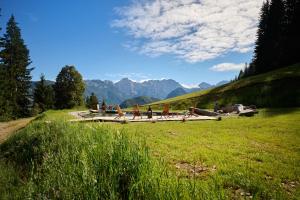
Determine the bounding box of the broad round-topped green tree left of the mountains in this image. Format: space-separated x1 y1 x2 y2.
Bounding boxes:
54 65 85 109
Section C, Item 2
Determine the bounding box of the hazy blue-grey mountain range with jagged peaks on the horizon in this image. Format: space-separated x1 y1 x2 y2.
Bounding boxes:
31 78 228 104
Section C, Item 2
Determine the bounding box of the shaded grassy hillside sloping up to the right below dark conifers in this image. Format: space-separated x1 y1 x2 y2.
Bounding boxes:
151 64 300 110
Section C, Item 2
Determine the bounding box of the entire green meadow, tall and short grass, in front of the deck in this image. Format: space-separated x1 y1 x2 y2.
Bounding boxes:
0 108 300 199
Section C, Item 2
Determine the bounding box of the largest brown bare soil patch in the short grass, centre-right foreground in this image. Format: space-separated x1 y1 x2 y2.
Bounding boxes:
175 161 217 177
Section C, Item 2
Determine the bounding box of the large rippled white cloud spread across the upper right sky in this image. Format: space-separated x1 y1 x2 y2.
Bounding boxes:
112 0 263 62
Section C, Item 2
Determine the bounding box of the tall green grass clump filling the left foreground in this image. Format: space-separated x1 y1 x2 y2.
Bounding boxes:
0 120 227 199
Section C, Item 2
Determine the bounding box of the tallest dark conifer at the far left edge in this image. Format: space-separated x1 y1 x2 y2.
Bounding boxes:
0 16 32 118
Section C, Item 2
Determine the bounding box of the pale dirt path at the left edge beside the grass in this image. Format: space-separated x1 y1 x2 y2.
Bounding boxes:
0 117 34 143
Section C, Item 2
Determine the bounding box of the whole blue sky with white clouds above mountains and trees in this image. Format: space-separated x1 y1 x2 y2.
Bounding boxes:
0 0 262 85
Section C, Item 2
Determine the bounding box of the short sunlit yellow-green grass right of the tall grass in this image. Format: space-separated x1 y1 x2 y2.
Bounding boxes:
96 108 300 198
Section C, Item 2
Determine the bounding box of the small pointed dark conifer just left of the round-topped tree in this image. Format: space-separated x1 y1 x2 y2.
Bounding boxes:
33 74 54 111
